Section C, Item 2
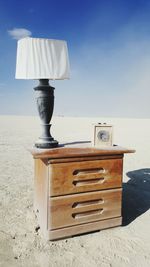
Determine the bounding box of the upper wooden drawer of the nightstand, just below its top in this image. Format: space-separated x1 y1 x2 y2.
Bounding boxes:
49 159 123 196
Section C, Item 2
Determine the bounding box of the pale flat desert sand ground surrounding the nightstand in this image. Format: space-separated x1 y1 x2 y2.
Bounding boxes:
0 116 150 267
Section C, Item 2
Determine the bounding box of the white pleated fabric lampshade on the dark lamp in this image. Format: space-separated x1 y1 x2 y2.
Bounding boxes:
16 37 69 80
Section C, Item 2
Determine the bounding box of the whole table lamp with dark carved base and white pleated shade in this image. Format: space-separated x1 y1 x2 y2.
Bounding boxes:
16 37 69 148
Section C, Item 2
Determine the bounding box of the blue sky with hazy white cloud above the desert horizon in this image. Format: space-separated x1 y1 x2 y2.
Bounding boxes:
0 0 150 118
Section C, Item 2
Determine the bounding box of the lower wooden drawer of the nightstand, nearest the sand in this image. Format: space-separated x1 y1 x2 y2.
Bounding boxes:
49 189 122 229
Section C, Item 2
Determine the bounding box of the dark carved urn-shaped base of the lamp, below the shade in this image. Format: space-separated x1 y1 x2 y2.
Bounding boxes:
34 79 58 148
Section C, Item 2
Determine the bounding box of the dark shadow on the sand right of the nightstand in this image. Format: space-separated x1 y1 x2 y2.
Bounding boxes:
122 169 150 226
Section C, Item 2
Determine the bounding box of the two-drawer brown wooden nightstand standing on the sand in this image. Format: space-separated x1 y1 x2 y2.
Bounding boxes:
32 146 134 240
